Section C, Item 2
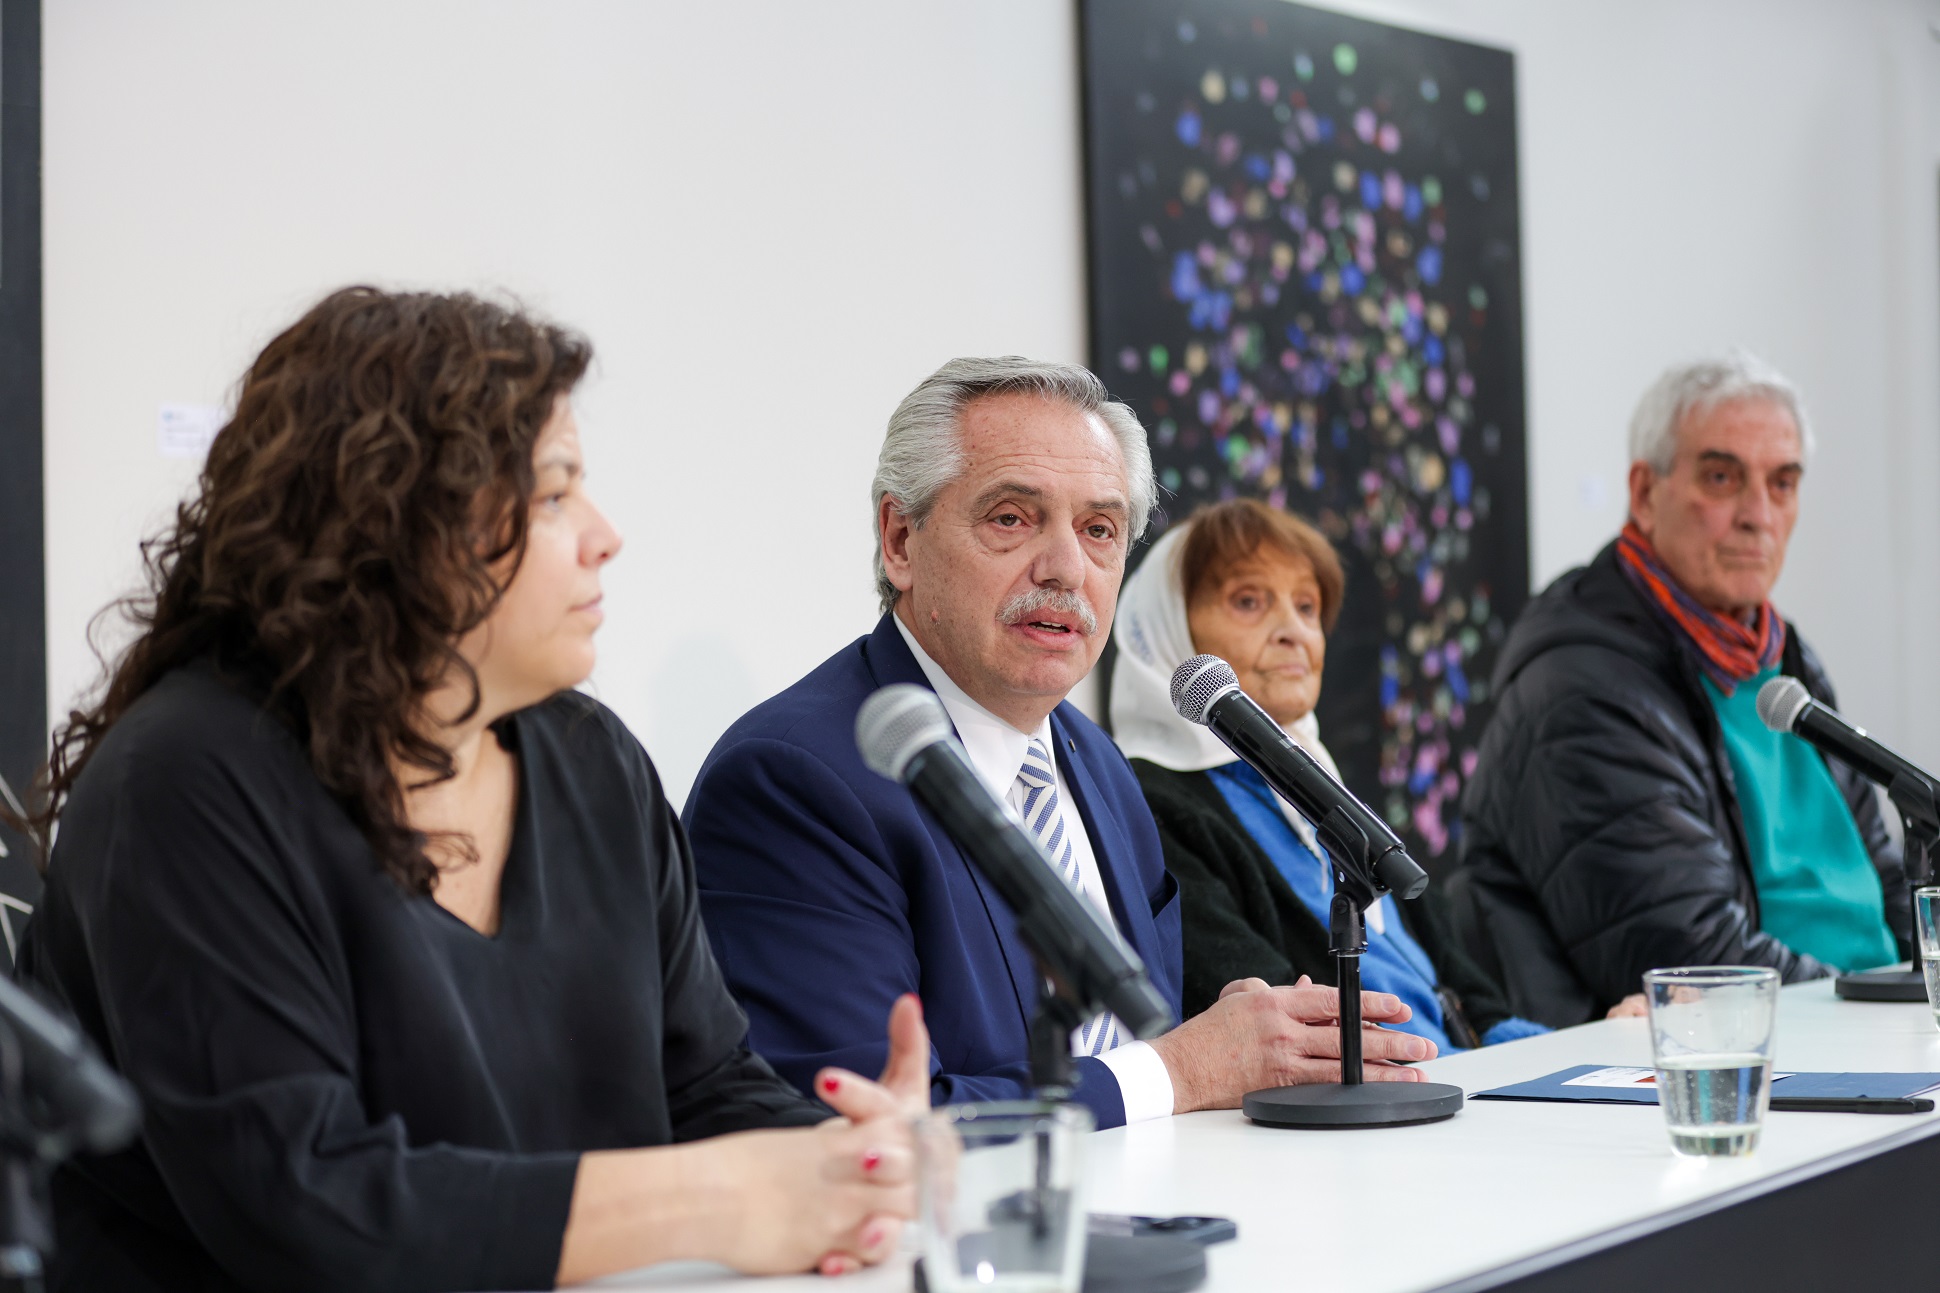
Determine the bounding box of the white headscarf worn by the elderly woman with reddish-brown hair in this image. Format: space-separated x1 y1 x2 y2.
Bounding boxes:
1112 522 1387 932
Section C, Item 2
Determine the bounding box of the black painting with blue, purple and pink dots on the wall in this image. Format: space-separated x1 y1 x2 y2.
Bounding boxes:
1083 0 1529 872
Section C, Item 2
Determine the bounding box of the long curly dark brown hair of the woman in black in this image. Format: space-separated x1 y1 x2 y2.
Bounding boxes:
19 287 592 893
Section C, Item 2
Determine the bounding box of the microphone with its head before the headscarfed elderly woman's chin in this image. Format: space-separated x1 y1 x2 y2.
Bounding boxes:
1172 656 1428 899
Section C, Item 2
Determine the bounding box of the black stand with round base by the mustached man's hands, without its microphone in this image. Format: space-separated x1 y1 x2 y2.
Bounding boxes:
1240 810 1465 1130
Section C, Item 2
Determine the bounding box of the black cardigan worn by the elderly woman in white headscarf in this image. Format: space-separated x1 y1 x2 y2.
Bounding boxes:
1131 759 1509 1046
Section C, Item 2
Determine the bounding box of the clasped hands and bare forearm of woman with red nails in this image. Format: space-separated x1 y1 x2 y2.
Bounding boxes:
559 998 929 1283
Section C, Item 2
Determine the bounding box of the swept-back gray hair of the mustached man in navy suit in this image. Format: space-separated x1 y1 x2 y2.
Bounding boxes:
871 355 1158 613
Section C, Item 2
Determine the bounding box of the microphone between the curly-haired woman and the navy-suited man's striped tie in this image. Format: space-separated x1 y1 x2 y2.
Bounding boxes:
856 683 1172 1039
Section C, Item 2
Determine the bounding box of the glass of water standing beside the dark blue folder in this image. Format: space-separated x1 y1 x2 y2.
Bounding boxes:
1643 965 1779 1157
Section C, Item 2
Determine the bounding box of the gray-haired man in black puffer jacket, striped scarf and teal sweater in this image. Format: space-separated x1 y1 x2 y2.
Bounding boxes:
1451 353 1909 1027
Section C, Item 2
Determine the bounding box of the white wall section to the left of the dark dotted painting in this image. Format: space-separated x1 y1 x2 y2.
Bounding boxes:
45 0 1084 800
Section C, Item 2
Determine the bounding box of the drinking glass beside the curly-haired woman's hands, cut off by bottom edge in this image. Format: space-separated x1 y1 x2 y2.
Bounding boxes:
916 1101 1092 1293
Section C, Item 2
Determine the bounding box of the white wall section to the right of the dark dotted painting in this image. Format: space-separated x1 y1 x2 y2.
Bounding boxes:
1329 0 1940 767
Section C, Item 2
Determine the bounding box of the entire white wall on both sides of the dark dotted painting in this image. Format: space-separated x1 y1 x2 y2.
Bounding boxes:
45 0 1940 798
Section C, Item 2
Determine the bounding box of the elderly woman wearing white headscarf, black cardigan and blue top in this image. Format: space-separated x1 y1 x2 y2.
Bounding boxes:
1112 499 1546 1050
